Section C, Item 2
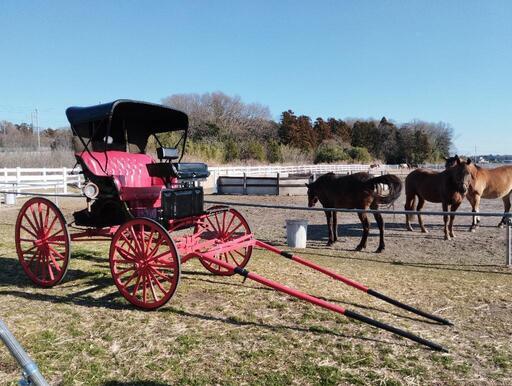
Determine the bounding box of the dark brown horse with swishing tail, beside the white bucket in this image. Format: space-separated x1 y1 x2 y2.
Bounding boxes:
306 173 402 253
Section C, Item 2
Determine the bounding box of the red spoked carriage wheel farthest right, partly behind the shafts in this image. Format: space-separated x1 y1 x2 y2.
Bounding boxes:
196 206 252 276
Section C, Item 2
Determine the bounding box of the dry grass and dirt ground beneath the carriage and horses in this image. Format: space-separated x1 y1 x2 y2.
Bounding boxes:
0 196 512 385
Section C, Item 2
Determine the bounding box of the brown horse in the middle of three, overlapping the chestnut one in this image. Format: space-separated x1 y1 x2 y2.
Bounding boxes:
405 158 471 240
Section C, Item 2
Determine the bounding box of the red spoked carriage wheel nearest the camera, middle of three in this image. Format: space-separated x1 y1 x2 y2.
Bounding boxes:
109 218 181 310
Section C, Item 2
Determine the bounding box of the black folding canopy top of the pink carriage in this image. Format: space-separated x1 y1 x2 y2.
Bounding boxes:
66 99 188 152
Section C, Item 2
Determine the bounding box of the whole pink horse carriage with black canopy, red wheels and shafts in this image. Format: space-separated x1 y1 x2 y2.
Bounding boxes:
15 100 450 351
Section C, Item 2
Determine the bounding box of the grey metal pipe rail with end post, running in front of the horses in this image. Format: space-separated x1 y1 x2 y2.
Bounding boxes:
204 200 512 268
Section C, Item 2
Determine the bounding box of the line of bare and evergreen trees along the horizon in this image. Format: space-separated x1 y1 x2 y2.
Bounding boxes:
0 92 453 164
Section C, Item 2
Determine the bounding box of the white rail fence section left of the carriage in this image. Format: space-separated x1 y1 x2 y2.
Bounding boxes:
0 168 83 193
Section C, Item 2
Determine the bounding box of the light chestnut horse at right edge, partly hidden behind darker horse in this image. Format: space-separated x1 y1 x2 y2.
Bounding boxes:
445 155 512 232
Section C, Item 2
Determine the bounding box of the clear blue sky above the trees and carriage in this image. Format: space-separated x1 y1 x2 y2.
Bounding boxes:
0 0 512 154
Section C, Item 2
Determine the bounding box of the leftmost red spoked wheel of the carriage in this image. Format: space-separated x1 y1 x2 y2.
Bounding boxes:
14 197 71 287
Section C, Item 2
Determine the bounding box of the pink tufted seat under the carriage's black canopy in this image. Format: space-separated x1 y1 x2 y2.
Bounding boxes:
77 150 165 201
